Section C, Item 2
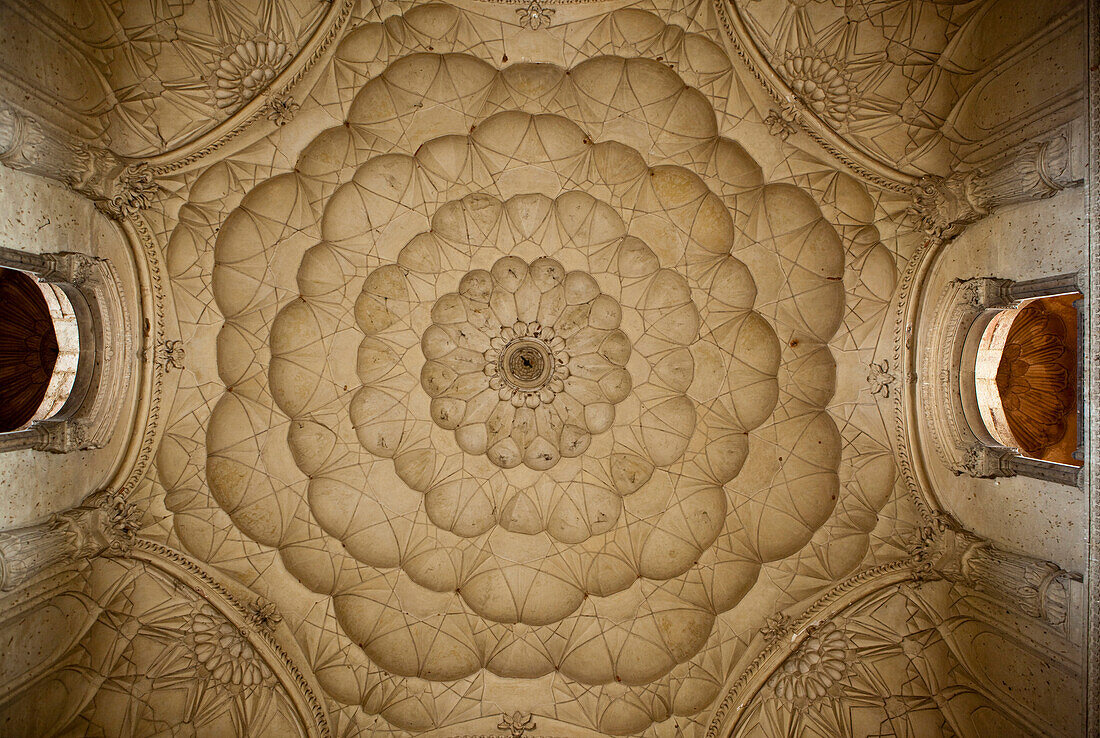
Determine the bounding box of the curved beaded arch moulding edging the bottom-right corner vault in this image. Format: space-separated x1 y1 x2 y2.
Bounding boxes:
705 557 922 738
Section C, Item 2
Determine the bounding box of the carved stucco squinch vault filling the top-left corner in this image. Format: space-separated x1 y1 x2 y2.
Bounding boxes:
0 0 329 156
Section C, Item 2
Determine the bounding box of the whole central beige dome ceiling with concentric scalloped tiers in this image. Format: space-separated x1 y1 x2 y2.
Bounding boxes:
146 5 905 735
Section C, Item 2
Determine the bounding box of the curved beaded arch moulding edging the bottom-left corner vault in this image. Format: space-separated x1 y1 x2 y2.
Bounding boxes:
127 538 332 738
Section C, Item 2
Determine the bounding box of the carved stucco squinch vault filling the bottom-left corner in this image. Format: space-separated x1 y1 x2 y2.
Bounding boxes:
0 558 316 737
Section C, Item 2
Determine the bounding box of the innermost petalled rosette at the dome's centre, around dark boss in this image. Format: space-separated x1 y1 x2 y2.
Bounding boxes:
420 256 631 470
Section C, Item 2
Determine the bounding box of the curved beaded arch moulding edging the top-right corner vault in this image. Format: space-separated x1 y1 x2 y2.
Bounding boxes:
714 0 917 192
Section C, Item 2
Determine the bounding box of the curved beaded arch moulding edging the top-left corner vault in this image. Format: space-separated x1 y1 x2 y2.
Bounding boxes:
146 0 356 177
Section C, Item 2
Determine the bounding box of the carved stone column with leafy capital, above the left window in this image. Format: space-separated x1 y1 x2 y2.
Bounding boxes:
0 101 157 220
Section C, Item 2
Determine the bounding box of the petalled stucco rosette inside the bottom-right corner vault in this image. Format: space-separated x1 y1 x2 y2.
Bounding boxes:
768 621 848 708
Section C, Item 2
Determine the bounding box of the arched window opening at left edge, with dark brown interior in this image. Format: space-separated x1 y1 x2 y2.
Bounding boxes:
0 268 80 432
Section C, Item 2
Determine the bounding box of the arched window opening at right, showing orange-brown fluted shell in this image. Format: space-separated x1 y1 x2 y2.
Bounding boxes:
975 293 1081 466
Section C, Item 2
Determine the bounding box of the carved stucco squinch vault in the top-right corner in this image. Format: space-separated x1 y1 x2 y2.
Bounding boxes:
730 0 1075 175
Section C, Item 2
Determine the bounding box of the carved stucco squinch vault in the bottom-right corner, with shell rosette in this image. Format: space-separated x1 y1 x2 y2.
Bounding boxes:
733 583 1081 738
